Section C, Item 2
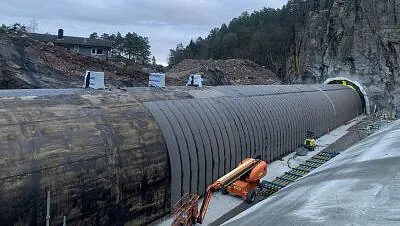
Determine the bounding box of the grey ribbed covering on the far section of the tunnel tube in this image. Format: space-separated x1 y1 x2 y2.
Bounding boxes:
145 85 361 203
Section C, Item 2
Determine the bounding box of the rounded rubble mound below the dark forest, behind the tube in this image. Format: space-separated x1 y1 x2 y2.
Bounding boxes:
167 59 280 86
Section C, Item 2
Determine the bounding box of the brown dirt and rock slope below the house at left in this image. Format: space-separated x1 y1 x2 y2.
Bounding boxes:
0 33 148 89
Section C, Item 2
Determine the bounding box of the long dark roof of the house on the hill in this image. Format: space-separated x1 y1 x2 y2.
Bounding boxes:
29 33 112 48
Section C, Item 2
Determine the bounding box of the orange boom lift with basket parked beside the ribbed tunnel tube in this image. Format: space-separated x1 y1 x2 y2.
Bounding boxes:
172 158 267 226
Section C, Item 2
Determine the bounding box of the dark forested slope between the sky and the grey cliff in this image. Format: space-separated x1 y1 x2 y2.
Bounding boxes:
168 0 319 80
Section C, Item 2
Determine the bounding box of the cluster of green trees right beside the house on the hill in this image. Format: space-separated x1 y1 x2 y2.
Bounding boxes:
89 32 152 65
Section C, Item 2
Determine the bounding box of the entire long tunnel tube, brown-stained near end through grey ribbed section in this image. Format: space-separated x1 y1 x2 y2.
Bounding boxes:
0 85 362 225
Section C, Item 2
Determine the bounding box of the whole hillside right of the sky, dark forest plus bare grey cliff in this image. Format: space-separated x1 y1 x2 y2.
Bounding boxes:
170 0 400 117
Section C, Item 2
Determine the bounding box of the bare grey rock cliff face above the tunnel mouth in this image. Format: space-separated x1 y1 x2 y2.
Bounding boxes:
287 0 400 116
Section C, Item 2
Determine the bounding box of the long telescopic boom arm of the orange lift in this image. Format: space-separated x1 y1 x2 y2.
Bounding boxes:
197 158 260 224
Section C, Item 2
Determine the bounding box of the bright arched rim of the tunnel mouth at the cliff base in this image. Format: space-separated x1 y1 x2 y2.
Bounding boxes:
324 77 371 114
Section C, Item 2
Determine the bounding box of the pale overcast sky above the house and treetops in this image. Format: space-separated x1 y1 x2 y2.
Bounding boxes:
0 0 287 64
